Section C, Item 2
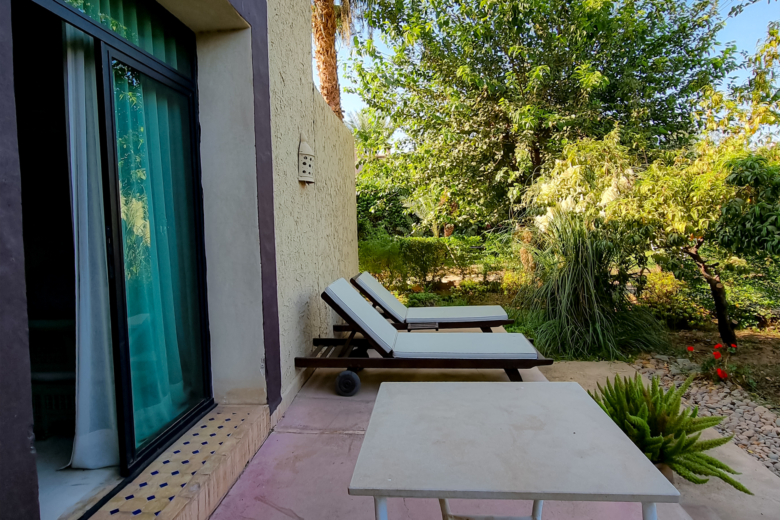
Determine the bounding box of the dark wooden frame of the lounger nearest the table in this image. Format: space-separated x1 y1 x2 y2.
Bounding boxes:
295 292 553 381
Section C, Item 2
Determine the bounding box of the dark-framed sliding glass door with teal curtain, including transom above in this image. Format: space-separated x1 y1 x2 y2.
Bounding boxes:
24 0 214 475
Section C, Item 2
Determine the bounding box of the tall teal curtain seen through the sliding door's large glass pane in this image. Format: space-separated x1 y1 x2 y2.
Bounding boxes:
113 62 205 446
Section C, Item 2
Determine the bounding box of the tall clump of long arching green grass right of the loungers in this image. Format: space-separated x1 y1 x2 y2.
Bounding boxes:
515 211 667 359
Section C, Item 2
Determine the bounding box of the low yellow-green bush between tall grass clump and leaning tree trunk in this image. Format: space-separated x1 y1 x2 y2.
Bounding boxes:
639 271 711 328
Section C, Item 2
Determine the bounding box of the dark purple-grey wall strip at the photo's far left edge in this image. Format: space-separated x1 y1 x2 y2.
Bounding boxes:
0 0 41 520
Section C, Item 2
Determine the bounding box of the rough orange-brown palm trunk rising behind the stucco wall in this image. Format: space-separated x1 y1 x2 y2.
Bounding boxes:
311 0 344 120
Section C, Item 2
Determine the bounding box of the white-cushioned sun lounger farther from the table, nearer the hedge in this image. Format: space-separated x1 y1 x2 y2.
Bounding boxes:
352 272 514 332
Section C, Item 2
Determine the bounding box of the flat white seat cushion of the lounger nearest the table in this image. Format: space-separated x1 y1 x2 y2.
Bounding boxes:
393 332 537 359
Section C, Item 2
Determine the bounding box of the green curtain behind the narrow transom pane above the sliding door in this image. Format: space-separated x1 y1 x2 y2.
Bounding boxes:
65 0 192 76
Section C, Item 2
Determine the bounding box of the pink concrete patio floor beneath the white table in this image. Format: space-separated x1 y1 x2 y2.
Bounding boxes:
212 369 691 520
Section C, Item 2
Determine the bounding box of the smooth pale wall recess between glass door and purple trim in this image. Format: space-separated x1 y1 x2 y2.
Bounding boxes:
197 29 266 404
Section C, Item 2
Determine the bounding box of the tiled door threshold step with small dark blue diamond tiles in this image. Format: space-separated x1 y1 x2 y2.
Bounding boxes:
78 405 277 520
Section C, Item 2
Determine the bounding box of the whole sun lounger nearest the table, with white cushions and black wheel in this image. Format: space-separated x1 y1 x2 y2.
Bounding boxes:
295 278 552 395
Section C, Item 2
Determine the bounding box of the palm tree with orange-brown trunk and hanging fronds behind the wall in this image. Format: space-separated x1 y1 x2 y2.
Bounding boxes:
311 0 371 119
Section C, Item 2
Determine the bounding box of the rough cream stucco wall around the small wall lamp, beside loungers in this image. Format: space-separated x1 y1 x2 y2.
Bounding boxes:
268 0 357 394
